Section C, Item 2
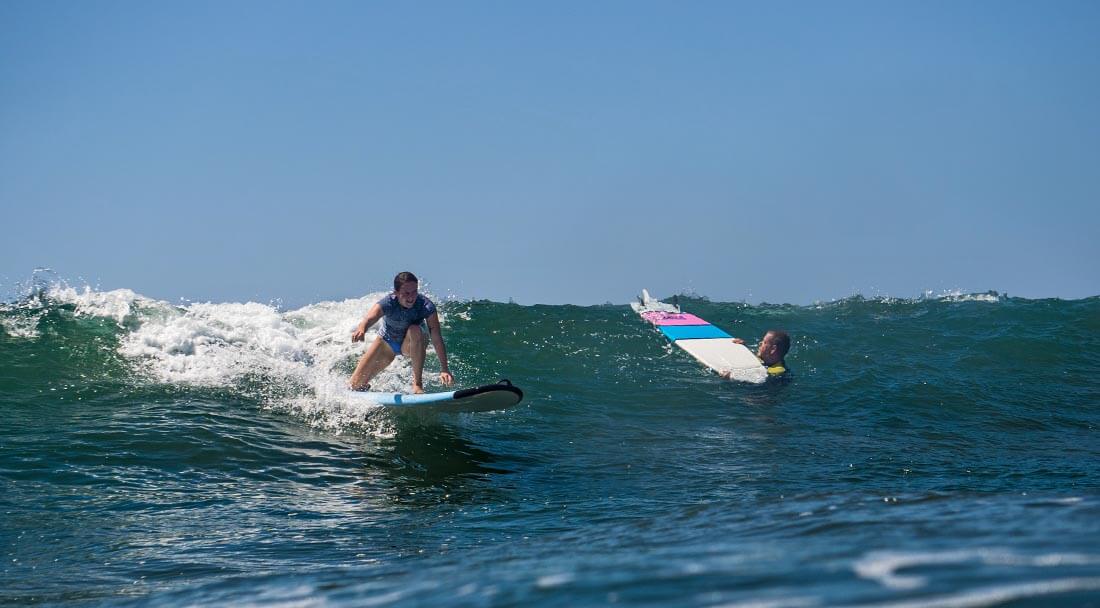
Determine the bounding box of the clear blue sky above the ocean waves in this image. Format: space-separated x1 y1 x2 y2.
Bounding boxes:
0 0 1100 308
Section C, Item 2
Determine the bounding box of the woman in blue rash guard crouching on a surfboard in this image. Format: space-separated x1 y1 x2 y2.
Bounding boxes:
351 273 454 394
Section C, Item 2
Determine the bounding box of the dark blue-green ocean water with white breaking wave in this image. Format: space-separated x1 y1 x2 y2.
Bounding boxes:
0 286 1100 607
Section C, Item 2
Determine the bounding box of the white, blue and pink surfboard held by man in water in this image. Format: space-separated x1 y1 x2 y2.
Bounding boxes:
630 289 768 384
